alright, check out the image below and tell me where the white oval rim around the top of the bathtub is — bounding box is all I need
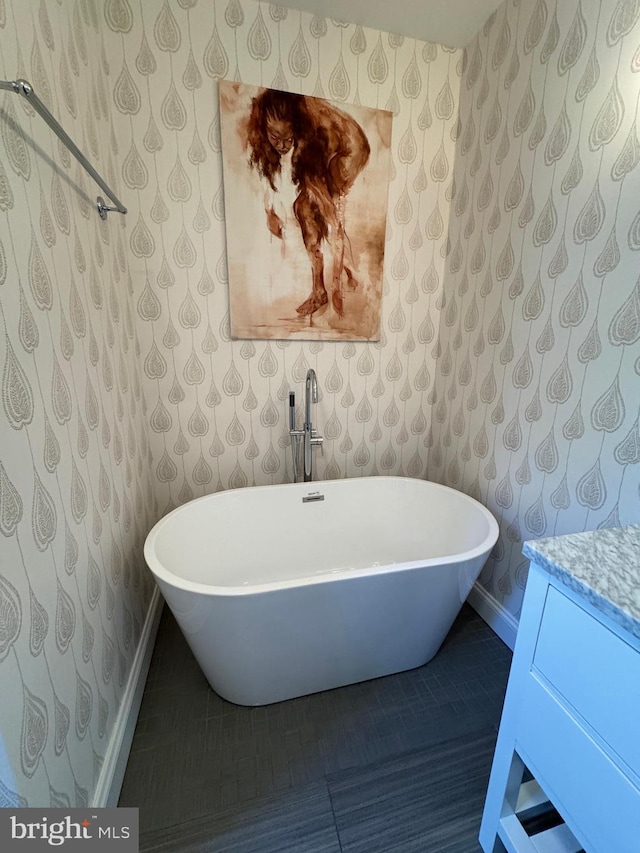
[144,477,500,597]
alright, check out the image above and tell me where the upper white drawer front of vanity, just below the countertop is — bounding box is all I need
[533,587,640,776]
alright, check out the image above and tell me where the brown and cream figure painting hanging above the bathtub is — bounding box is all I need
[220,80,392,341]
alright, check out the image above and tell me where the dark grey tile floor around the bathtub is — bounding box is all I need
[120,605,511,853]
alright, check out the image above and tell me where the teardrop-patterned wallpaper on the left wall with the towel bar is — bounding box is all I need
[0,0,155,807]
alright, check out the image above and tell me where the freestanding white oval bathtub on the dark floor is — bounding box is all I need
[144,477,498,705]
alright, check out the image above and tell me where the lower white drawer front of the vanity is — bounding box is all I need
[515,672,640,853]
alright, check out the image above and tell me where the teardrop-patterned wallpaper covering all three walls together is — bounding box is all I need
[0,0,640,806]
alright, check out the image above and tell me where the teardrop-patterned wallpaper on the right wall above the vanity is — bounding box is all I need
[428,0,640,615]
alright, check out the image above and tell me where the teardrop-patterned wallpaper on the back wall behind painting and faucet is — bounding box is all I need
[105,0,462,510]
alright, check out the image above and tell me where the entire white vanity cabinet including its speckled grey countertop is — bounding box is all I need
[480,528,640,853]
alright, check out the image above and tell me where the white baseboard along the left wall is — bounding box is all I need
[92,587,164,808]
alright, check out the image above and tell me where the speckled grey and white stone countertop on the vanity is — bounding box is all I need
[522,525,640,637]
